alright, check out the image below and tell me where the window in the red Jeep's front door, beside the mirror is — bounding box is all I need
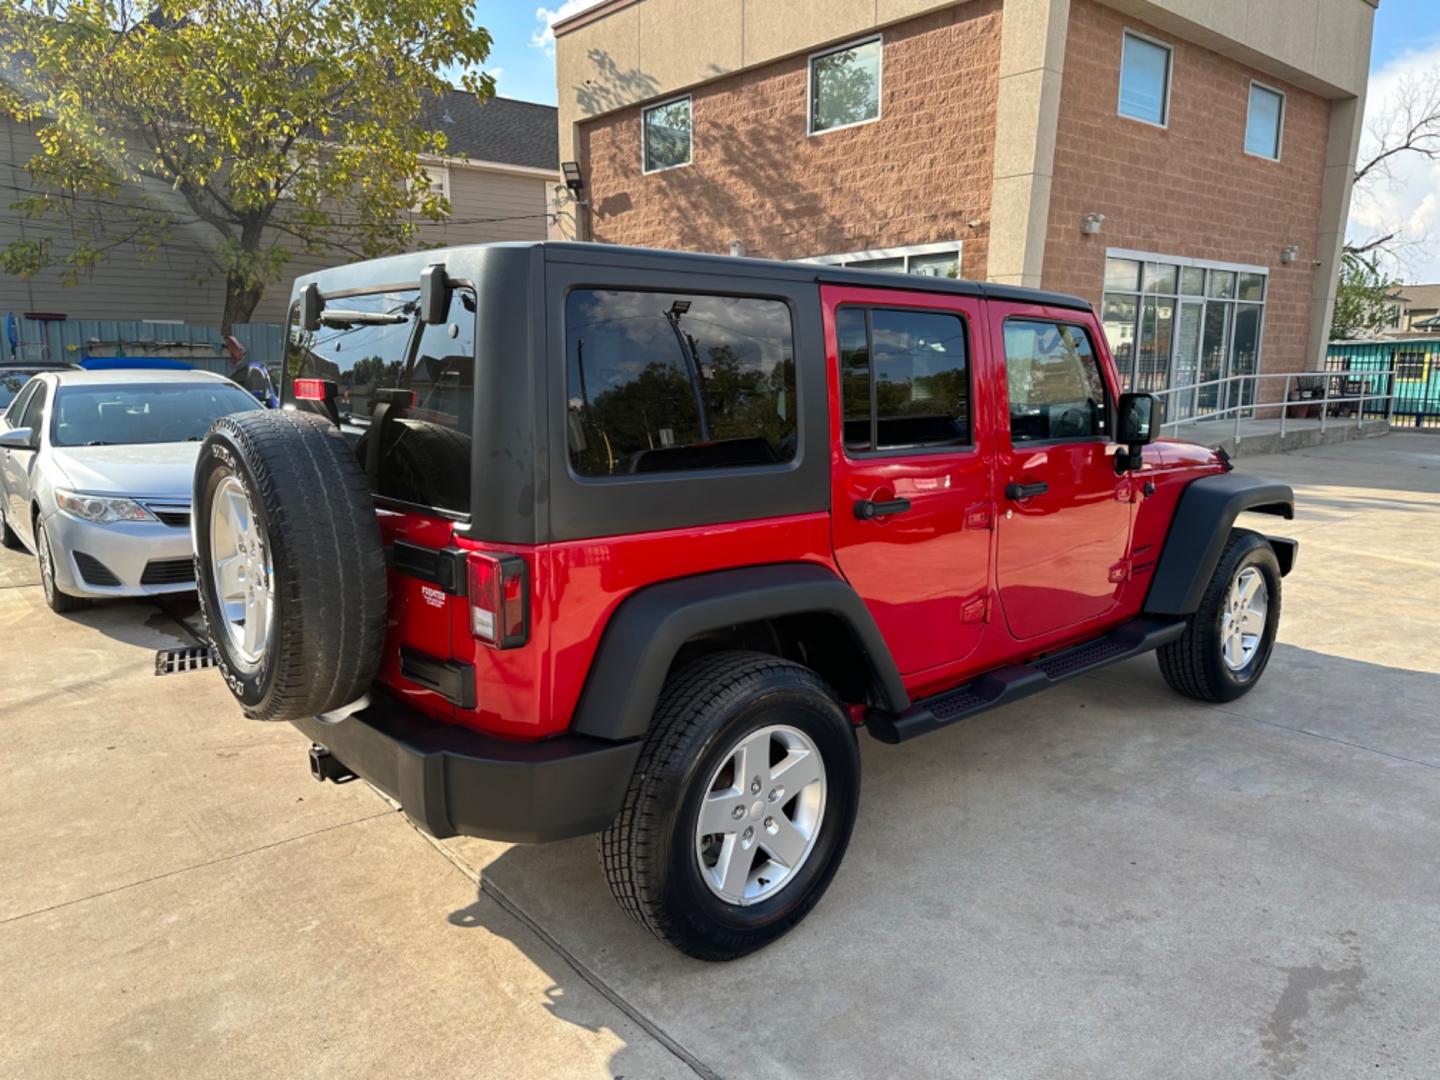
[1005,318,1110,444]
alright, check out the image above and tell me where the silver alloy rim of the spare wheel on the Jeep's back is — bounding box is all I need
[210,475,275,671]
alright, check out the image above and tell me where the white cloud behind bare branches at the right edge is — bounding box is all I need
[1346,42,1440,282]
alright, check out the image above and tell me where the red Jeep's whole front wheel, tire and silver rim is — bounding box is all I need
[1156,528,1280,703]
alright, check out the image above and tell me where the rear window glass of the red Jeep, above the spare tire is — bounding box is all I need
[282,288,475,514]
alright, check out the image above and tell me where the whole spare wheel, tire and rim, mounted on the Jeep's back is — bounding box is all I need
[192,412,386,720]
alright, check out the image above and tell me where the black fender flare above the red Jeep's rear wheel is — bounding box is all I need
[570,563,910,740]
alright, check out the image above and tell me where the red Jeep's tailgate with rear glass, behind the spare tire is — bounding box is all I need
[282,288,475,717]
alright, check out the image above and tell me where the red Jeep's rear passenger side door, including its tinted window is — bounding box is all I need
[824,287,994,674]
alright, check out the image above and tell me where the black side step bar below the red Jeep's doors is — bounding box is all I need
[865,619,1185,743]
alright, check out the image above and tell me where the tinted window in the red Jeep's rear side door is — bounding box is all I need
[835,308,971,452]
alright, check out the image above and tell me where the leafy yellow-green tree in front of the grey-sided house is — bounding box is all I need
[0,0,494,333]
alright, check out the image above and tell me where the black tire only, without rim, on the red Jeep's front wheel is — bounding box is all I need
[1156,528,1280,703]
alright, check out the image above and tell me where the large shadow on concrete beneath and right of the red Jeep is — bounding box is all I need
[448,645,1440,1077]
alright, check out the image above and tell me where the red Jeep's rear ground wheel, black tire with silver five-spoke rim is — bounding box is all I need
[600,652,860,960]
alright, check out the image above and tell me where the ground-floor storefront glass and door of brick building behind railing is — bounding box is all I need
[1100,251,1269,419]
